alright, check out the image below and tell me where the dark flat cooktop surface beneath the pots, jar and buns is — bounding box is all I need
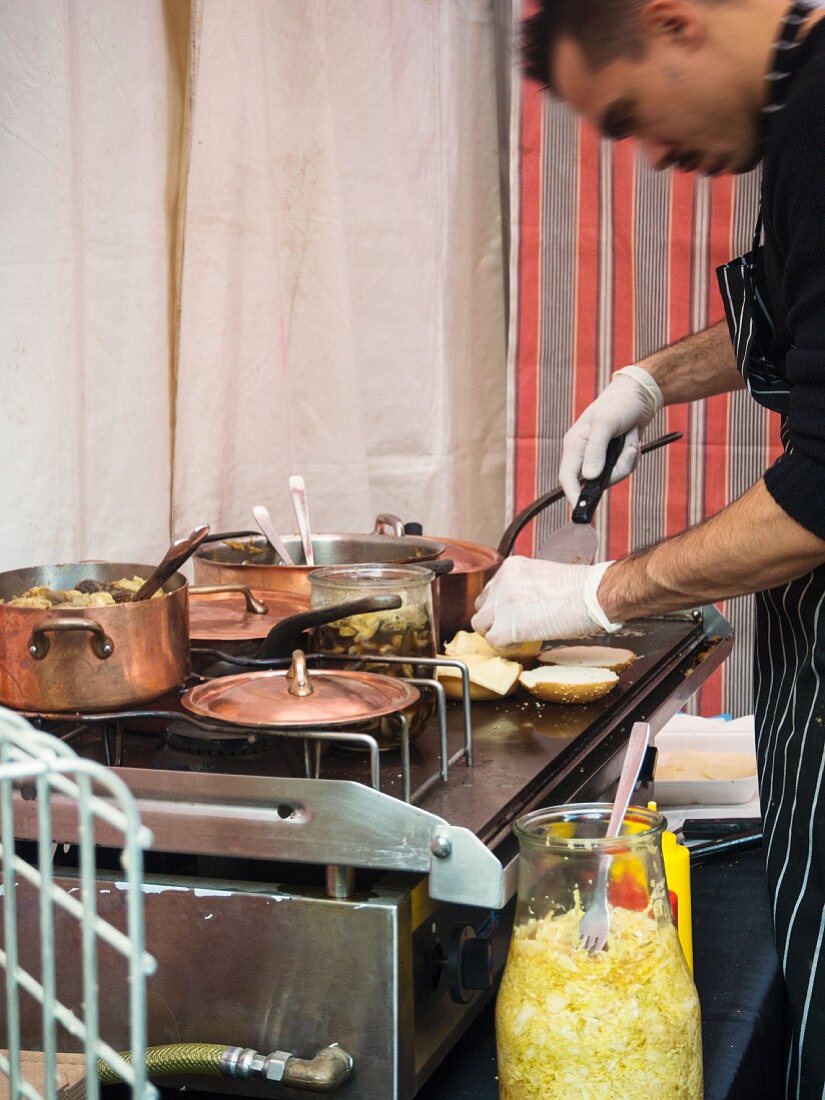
[40,618,727,844]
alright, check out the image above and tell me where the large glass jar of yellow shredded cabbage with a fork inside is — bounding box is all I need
[496,804,703,1100]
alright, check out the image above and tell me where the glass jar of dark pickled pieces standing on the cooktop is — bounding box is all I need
[309,564,436,748]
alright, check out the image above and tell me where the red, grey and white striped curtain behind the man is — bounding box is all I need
[509,75,780,715]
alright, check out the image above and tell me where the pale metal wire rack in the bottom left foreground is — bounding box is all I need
[0,708,157,1100]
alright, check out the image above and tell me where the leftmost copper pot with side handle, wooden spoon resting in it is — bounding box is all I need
[0,562,189,713]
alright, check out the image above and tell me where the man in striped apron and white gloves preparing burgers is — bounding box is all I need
[473,0,825,1098]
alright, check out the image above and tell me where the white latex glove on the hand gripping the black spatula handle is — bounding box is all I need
[559,364,663,507]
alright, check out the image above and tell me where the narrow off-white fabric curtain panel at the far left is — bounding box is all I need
[0,0,182,569]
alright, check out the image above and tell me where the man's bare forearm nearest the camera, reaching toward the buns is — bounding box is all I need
[598,480,825,623]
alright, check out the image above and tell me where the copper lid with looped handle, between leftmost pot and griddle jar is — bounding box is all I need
[189,584,309,641]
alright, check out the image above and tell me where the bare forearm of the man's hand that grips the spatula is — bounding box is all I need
[638,321,745,405]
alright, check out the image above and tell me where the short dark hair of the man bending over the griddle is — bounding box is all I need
[521,0,646,88]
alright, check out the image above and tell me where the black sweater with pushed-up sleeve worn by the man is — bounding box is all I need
[760,20,825,539]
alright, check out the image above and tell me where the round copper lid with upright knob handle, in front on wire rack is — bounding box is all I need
[180,650,419,729]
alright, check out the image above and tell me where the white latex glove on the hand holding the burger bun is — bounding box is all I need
[472,557,622,646]
